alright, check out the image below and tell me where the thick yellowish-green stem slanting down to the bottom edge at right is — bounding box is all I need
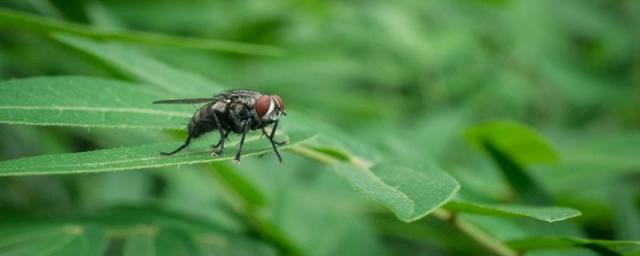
[433,208,519,256]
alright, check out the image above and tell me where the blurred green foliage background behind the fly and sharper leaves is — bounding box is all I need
[0,0,640,255]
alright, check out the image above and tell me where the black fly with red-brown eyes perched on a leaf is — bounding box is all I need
[153,90,286,163]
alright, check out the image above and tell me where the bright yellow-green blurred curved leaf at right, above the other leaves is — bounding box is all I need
[465,121,558,166]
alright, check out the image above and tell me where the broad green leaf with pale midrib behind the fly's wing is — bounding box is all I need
[0,76,193,129]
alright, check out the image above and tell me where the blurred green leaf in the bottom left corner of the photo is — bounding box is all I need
[0,224,107,256]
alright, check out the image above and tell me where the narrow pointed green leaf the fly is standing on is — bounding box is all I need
[0,131,314,176]
